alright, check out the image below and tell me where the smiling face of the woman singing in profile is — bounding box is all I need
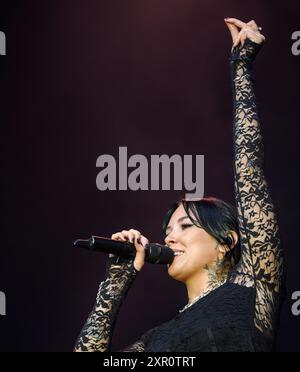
[165,204,219,282]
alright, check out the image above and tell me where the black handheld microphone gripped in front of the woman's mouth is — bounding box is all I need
[73,235,174,264]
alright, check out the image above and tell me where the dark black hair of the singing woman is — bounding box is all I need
[163,196,241,265]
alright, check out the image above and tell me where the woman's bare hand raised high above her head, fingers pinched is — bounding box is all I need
[224,18,266,51]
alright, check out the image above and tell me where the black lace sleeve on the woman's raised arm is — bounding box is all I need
[227,39,283,334]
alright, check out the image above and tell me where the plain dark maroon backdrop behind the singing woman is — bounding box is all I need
[0,0,300,351]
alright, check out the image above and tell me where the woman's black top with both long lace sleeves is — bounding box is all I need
[75,39,283,352]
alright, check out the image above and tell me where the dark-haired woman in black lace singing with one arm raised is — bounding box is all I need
[75,18,283,352]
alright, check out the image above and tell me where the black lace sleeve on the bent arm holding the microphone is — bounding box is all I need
[75,256,139,352]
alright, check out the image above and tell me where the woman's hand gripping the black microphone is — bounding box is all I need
[111,229,149,271]
